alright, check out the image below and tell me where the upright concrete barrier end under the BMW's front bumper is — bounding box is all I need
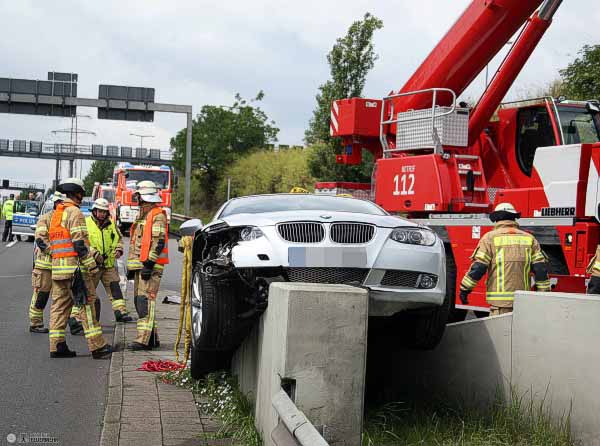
[232,283,368,446]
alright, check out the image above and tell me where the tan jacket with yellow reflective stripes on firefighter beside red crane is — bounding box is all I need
[461,221,550,307]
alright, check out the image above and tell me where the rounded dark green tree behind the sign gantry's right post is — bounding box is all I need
[171,91,279,208]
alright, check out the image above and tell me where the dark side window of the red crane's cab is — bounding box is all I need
[516,107,556,176]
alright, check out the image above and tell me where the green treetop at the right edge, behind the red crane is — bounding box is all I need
[560,45,600,100]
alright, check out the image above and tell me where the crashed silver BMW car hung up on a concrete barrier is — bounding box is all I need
[181,194,449,376]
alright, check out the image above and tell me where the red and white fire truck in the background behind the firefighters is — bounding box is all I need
[112,163,174,233]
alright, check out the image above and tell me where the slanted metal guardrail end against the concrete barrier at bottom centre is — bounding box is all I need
[271,389,329,446]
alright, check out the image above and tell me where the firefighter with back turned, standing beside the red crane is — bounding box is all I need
[460,203,550,316]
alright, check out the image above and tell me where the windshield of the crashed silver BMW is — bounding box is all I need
[218,194,387,218]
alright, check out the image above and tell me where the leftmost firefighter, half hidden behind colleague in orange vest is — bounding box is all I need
[29,192,65,333]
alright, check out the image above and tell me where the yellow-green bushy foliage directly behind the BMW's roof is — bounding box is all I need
[219,149,315,201]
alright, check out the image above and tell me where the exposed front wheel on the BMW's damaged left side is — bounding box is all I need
[190,262,251,376]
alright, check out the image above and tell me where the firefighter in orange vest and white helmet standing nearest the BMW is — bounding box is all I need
[127,181,169,350]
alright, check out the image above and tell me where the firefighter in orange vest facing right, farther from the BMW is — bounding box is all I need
[49,178,112,359]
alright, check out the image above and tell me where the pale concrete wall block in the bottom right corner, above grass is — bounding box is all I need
[513,292,600,445]
